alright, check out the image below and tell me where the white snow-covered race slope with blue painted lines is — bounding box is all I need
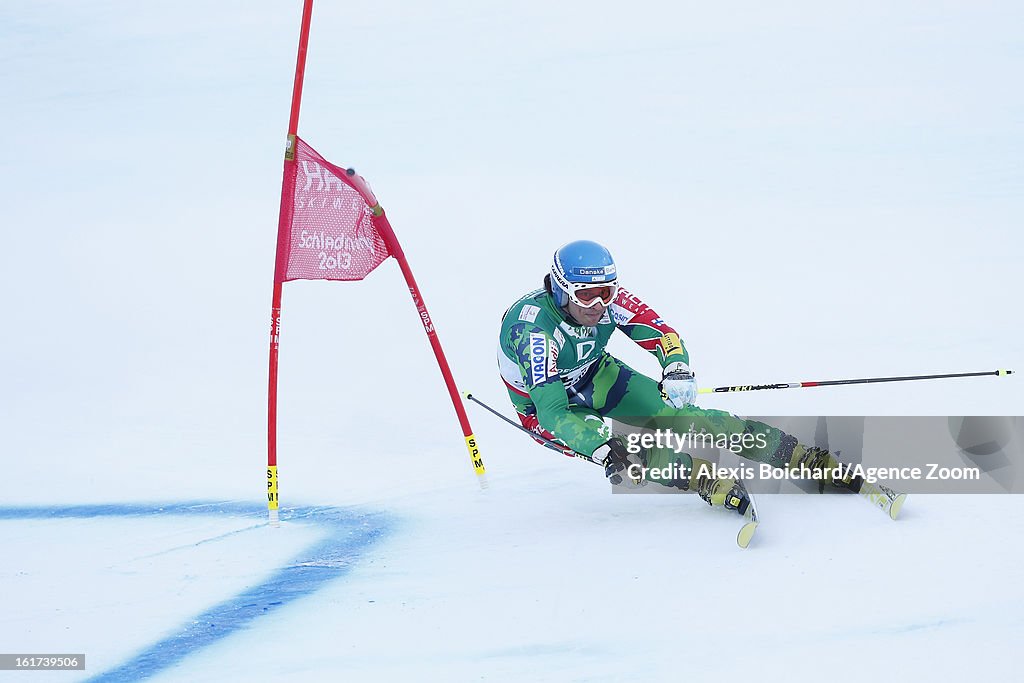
[0,0,1024,681]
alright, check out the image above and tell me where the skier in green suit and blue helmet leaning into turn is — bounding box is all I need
[498,240,859,514]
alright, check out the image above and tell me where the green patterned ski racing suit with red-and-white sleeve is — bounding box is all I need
[498,288,795,485]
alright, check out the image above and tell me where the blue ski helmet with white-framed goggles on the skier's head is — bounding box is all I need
[551,240,618,308]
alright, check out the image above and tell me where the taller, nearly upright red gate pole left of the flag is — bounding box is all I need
[266,0,313,526]
